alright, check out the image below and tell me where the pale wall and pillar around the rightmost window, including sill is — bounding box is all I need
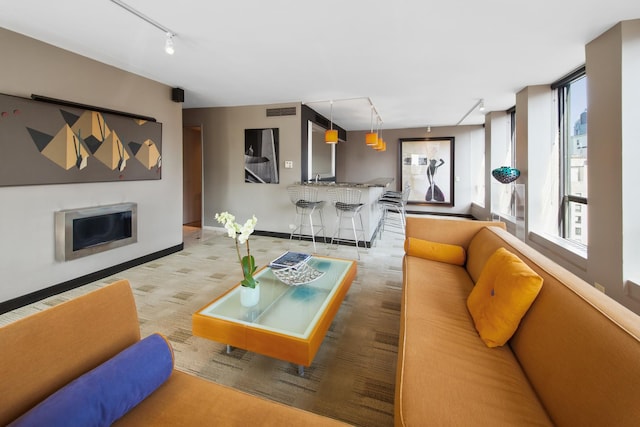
[496,20,640,313]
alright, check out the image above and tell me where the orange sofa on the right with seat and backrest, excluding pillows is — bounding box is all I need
[395,218,640,426]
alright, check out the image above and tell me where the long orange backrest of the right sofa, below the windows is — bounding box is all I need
[469,229,640,426]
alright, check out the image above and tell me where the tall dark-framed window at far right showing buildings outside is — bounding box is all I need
[552,67,588,245]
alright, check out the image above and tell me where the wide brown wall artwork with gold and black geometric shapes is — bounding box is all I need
[0,94,162,186]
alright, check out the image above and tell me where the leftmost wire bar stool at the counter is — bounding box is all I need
[287,185,327,252]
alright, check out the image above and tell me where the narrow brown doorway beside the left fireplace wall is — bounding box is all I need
[182,126,202,228]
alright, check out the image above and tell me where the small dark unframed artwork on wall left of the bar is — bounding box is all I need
[244,128,280,184]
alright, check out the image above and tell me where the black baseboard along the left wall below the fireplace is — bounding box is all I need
[0,243,184,314]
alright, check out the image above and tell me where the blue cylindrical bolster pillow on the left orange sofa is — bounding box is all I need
[10,334,173,427]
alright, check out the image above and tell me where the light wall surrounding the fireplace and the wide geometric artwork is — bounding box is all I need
[0,28,182,302]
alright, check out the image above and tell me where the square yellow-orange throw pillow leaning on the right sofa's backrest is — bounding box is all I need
[467,248,542,347]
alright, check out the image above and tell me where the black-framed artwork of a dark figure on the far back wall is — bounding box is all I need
[399,137,455,206]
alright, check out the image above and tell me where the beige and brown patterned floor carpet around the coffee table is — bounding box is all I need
[0,228,404,426]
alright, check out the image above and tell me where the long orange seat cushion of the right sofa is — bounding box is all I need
[394,252,552,426]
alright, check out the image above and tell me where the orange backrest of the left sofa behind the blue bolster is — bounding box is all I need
[0,281,140,425]
